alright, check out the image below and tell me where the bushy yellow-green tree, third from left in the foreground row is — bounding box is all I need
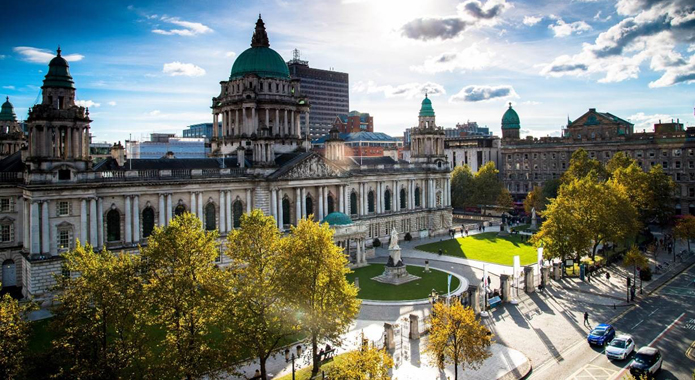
[142,213,228,379]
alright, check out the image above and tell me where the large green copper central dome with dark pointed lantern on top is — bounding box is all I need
[229,15,290,80]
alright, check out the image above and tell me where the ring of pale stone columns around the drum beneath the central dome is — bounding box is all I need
[212,106,309,138]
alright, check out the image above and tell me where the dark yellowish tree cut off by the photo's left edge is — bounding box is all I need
[0,284,34,379]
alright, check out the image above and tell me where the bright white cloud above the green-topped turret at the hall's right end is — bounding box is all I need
[410,43,495,74]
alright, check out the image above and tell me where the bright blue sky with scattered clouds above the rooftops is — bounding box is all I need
[0,0,695,142]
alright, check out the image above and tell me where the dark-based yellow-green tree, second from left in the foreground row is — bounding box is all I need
[53,242,150,379]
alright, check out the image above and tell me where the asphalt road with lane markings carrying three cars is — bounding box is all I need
[530,265,695,380]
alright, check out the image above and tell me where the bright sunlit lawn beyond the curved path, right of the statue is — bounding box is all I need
[416,232,538,266]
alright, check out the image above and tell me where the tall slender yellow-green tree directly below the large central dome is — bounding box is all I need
[225,210,298,379]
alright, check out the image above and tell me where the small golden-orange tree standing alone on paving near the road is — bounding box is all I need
[424,302,492,379]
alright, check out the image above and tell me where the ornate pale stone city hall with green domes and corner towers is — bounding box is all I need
[0,18,452,296]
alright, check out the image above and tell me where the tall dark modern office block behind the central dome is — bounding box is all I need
[287,49,350,139]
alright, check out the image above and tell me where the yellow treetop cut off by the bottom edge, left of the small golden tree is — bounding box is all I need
[328,343,394,380]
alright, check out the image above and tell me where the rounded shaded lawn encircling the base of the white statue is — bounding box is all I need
[347,264,460,301]
